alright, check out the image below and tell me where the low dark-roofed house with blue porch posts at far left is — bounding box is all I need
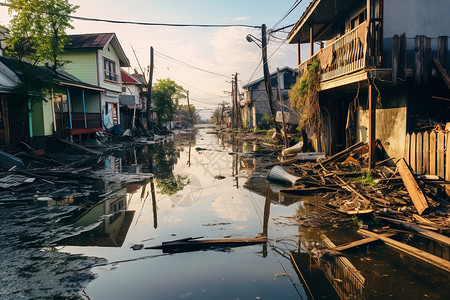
[0,56,102,144]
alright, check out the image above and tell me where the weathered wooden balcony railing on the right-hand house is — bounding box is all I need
[299,21,368,81]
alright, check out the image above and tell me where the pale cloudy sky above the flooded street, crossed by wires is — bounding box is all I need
[0,0,311,118]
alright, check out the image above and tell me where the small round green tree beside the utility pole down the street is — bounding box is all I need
[152,78,186,125]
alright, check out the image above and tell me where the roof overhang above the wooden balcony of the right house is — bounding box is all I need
[288,0,365,44]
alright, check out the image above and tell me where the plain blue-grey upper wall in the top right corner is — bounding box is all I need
[383,0,450,38]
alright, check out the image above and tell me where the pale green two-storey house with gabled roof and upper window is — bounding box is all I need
[61,33,130,129]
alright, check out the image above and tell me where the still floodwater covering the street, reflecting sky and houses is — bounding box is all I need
[0,128,450,299]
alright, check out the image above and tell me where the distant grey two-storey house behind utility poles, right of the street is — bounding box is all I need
[241,67,298,128]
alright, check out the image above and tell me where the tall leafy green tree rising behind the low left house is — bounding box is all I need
[5,0,79,73]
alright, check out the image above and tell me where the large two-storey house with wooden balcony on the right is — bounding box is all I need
[288,0,450,172]
